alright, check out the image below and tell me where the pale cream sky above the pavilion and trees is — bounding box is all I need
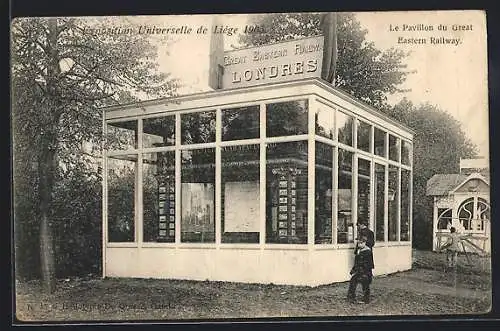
[116,11,489,157]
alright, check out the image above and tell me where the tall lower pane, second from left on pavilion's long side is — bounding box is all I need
[142,152,176,242]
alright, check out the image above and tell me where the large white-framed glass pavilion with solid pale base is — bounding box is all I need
[103,35,412,285]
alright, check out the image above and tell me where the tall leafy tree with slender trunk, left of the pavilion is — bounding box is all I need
[11,18,176,291]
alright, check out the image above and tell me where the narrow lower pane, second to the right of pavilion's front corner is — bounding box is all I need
[337,148,354,244]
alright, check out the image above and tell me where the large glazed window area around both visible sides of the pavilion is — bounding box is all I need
[106,94,412,248]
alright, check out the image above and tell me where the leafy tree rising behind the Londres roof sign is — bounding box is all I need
[240,13,409,107]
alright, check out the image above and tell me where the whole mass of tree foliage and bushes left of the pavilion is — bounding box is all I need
[11,18,177,278]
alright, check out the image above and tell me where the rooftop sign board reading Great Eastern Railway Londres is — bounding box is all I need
[222,36,323,89]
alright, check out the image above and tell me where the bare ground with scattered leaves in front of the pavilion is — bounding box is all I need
[16,251,491,321]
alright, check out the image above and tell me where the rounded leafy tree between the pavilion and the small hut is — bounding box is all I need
[389,99,478,248]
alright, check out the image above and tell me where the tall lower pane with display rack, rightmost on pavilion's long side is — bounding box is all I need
[266,141,308,244]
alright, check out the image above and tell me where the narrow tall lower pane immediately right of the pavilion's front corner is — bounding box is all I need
[314,142,333,244]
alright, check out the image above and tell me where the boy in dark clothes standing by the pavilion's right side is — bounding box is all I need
[347,236,374,303]
